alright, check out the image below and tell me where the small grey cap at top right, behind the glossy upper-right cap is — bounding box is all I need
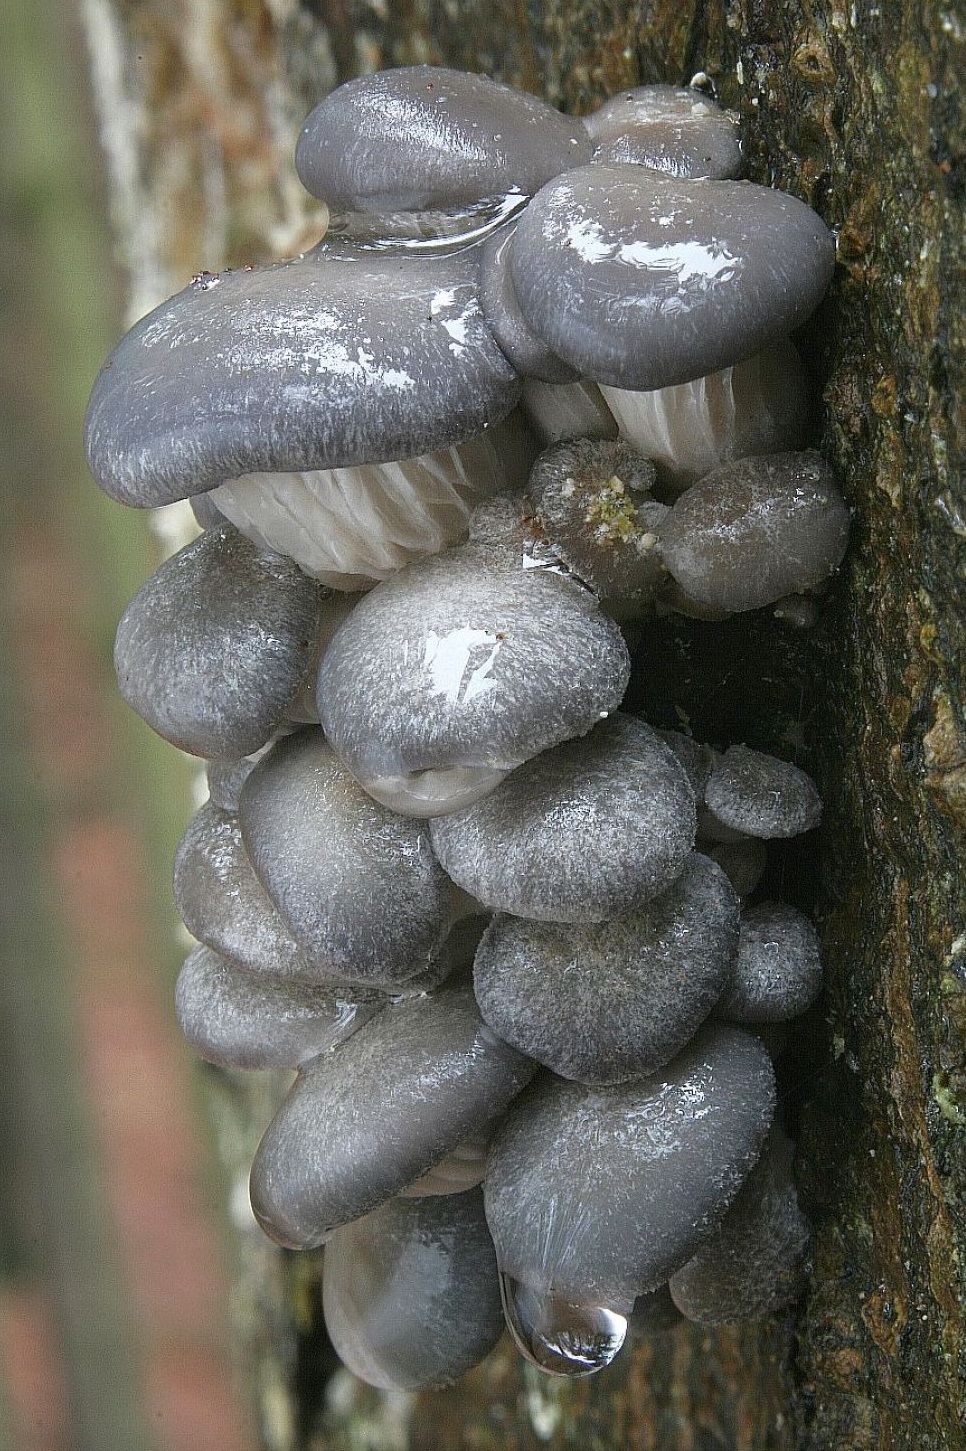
[583,86,741,180]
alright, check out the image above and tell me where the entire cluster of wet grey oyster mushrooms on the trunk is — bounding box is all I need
[87,67,849,1389]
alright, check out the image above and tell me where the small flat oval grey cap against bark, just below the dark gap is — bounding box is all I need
[701,746,822,840]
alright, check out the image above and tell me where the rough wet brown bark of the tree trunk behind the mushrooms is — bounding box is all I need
[81,0,966,1451]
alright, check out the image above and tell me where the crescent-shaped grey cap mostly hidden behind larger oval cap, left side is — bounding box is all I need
[174,801,319,982]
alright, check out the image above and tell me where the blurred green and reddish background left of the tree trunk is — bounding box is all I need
[0,0,255,1451]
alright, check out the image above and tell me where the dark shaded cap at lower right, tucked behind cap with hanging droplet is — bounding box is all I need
[670,1129,809,1325]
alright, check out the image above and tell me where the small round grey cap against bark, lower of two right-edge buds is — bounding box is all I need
[717,903,822,1023]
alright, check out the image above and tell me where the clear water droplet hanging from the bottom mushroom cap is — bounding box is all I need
[500,1274,627,1376]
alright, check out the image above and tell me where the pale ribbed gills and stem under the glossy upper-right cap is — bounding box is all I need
[600,338,812,493]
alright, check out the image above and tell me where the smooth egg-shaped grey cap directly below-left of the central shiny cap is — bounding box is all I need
[239,730,453,987]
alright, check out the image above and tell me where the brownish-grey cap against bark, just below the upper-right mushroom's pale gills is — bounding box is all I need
[657,450,849,611]
